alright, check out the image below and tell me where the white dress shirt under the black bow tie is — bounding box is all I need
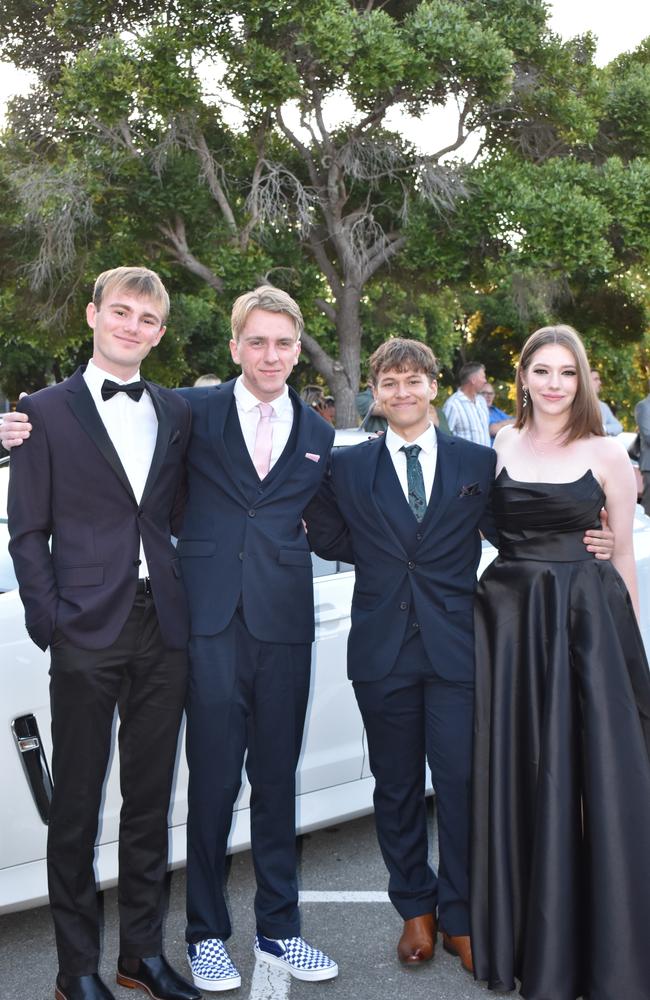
[83,359,158,578]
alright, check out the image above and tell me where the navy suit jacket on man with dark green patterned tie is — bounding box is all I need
[305,432,496,682]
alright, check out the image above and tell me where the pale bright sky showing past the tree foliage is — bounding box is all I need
[0,0,650,131]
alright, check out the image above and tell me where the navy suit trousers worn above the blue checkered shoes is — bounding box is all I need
[186,611,311,942]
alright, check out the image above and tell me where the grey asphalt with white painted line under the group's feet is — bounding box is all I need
[0,816,496,1000]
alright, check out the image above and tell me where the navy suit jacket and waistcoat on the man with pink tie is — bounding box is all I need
[178,380,334,643]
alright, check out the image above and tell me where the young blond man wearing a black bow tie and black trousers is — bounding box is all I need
[8,267,200,1000]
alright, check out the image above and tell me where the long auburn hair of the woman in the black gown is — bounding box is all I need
[515,324,605,444]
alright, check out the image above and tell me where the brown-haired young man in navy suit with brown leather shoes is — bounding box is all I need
[305,338,611,971]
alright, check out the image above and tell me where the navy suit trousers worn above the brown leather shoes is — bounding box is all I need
[354,634,474,935]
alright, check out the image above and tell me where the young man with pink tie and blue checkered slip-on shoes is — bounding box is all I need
[178,286,338,990]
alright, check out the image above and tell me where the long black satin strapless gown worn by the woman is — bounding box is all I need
[471,469,650,1000]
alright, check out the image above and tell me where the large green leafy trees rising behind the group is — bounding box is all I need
[0,0,650,424]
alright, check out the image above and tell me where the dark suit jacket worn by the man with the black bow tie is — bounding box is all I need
[8,368,191,649]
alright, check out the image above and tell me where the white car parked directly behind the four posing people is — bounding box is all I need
[0,440,650,913]
